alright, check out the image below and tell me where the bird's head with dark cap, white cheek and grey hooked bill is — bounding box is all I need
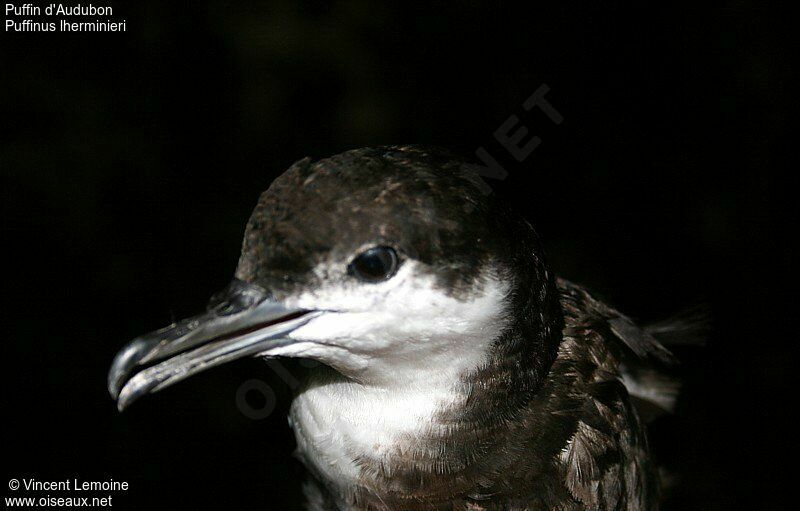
[108,146,558,409]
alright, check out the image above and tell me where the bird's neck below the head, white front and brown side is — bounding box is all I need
[291,276,561,508]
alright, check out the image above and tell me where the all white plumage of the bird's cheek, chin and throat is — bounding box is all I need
[265,262,508,494]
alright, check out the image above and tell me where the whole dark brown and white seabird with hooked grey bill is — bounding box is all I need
[108,145,677,511]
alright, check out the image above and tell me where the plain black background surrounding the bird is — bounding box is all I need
[0,1,797,510]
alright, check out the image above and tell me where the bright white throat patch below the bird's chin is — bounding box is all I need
[290,348,494,504]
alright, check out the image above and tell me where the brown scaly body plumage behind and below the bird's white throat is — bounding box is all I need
[306,279,670,511]
